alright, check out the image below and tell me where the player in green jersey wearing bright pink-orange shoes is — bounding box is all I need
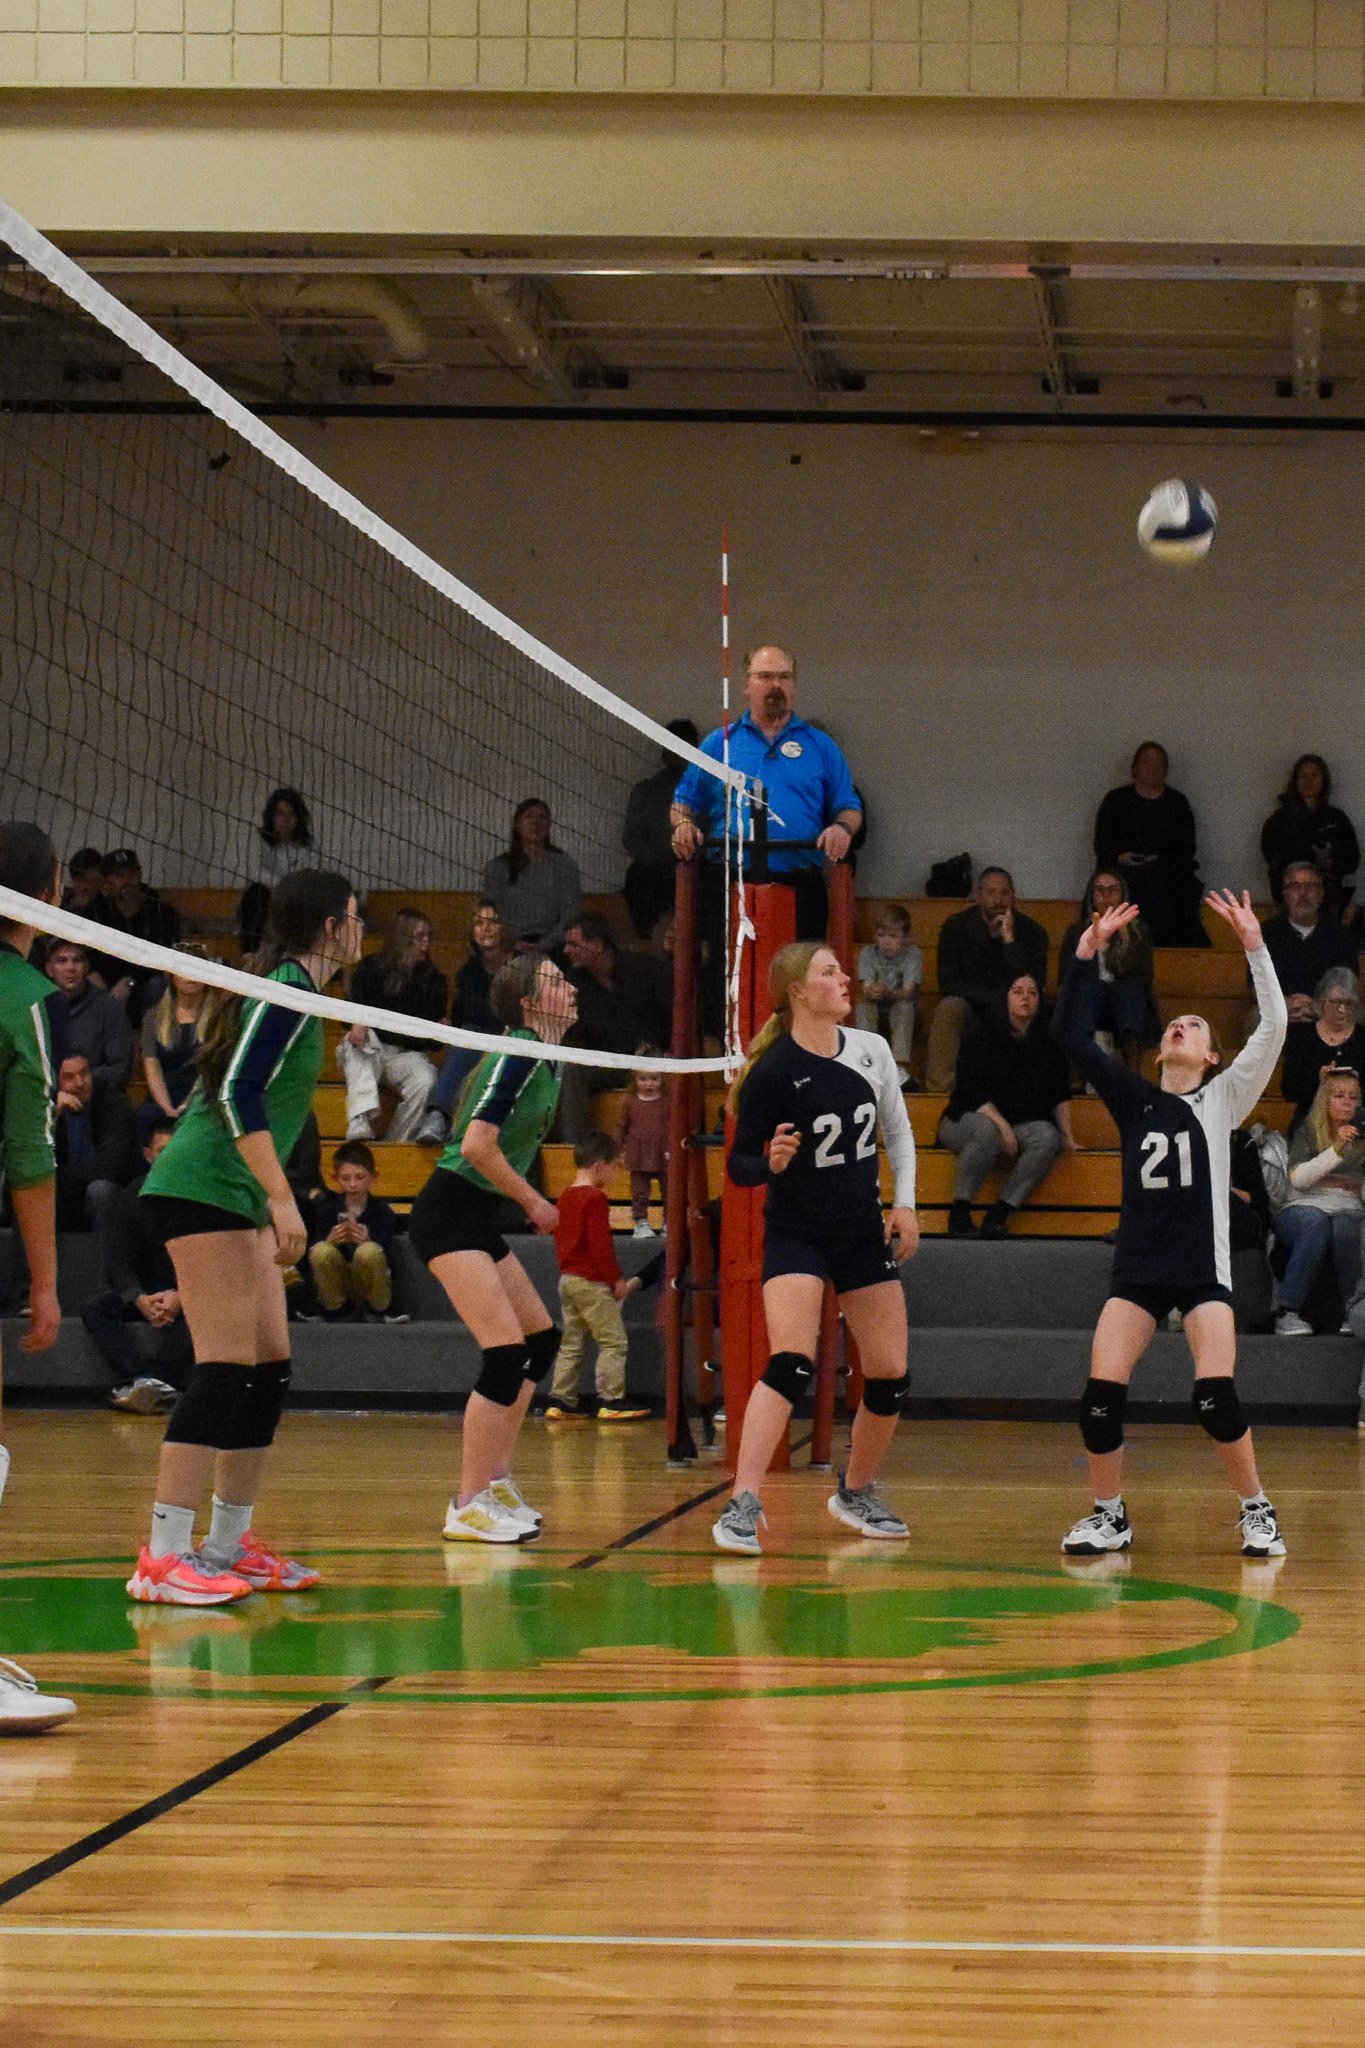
[129,868,362,1608]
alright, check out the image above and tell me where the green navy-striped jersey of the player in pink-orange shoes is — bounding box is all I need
[143,961,323,1229]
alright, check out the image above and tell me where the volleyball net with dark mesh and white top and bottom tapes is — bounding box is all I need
[0,205,747,1071]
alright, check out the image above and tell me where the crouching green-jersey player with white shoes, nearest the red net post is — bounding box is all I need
[407,954,577,1542]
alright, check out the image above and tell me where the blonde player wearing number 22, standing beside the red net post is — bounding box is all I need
[712,940,919,1554]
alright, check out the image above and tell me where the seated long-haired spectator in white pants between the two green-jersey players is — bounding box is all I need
[336,909,448,1145]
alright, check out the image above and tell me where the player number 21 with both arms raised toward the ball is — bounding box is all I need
[1052,889,1287,1556]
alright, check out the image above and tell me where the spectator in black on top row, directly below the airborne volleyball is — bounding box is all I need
[1095,739,1209,946]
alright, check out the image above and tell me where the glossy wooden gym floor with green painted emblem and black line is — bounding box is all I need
[0,1411,1365,2048]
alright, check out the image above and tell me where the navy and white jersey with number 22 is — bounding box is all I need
[729,1030,915,1239]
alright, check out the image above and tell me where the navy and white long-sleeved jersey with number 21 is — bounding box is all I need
[1052,946,1287,1288]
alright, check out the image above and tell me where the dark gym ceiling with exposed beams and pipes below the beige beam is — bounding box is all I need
[0,238,1365,424]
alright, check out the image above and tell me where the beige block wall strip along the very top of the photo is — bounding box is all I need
[0,0,1365,100]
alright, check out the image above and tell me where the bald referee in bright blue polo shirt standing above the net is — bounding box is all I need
[671,647,862,1034]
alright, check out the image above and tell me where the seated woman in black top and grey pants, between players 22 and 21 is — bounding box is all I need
[939,975,1076,1237]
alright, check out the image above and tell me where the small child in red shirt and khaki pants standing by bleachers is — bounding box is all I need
[546,1130,649,1421]
